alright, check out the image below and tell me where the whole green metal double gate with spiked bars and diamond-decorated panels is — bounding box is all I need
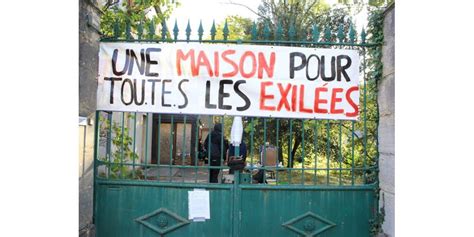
[94,19,380,237]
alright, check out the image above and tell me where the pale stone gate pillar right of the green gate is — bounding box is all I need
[378,5,395,237]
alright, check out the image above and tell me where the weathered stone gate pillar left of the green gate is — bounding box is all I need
[78,0,105,236]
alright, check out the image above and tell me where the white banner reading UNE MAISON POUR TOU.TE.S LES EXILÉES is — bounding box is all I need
[97,42,359,120]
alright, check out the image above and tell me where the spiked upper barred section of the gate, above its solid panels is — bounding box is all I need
[95,19,380,186]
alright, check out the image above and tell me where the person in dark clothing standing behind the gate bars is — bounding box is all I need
[204,123,229,183]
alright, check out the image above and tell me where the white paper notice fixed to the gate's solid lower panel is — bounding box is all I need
[188,189,211,221]
